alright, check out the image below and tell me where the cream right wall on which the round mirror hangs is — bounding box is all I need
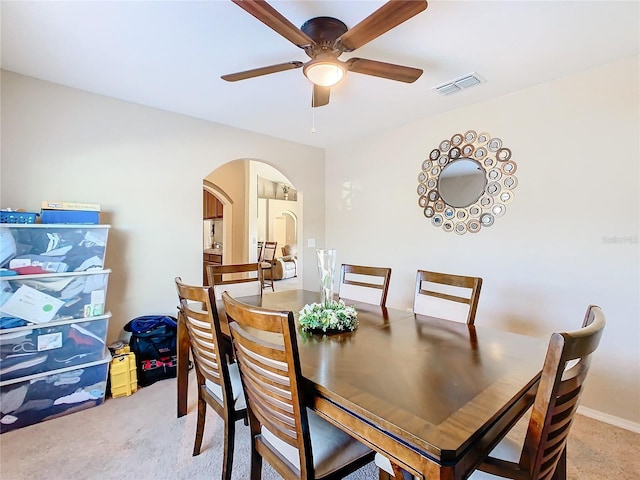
[326,54,640,427]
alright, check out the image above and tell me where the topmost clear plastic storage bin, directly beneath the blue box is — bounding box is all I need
[0,224,110,275]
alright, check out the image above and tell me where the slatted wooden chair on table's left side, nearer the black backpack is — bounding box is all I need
[175,277,247,480]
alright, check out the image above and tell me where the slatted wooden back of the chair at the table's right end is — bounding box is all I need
[520,305,606,480]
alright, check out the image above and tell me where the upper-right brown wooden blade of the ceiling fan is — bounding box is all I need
[337,0,427,52]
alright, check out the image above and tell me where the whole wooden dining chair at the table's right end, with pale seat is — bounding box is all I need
[376,305,606,480]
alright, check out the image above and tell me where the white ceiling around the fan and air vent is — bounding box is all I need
[0,0,640,147]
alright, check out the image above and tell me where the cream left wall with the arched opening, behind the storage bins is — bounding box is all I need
[0,71,324,340]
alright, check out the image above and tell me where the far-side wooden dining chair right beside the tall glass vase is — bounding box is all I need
[339,263,391,307]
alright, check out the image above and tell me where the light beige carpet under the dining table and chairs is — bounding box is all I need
[0,372,640,480]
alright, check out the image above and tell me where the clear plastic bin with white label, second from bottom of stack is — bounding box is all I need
[0,313,111,381]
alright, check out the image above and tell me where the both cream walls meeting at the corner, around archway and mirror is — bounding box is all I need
[0,58,640,425]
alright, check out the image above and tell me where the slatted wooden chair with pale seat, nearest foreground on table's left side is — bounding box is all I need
[222,292,374,480]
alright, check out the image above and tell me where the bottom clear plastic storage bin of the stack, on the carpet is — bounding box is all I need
[0,350,111,433]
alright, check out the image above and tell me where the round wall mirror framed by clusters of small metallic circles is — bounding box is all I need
[417,130,518,235]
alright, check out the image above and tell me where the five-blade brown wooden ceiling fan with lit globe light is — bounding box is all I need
[222,0,427,107]
